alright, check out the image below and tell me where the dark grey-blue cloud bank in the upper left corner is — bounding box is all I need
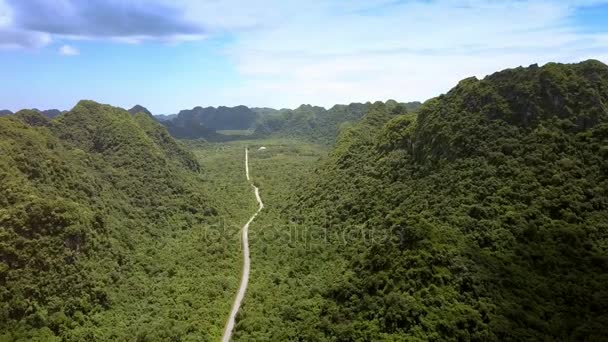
[0,0,205,48]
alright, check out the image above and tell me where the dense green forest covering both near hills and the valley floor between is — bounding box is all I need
[0,61,608,341]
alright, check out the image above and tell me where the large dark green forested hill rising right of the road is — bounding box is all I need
[243,61,608,341]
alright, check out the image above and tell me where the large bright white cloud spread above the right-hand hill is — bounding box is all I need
[194,0,608,107]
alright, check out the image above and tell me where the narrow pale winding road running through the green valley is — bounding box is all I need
[222,148,264,342]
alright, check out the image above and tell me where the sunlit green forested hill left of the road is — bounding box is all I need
[0,101,236,341]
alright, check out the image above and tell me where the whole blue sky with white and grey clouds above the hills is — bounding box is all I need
[0,0,608,114]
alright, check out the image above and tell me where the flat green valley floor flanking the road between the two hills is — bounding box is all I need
[190,139,327,341]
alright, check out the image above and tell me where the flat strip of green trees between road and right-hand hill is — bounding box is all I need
[233,139,338,341]
